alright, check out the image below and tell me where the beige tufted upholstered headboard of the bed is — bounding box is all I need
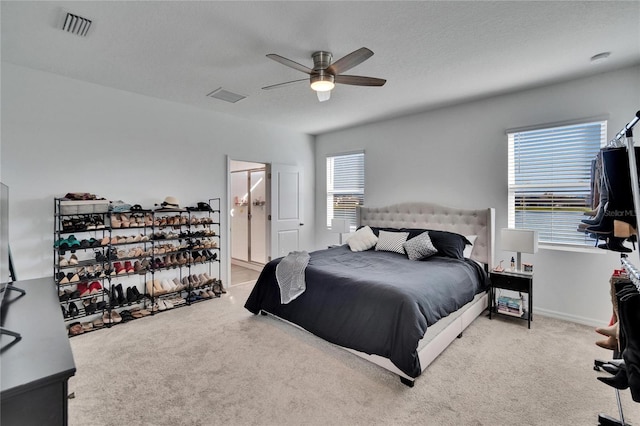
[358,202,495,268]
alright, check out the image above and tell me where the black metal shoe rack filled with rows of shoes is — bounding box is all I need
[53,198,224,337]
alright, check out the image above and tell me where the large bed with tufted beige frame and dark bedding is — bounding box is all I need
[245,203,495,386]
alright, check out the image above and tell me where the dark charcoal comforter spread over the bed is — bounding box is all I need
[245,245,488,377]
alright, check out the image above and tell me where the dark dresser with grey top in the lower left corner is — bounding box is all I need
[0,278,76,426]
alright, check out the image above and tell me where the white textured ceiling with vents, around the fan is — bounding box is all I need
[0,0,640,134]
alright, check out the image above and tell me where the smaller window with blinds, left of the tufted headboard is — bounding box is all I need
[327,152,364,230]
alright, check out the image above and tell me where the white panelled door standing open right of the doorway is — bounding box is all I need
[270,164,304,259]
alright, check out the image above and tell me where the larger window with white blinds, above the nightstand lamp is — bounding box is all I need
[508,121,607,246]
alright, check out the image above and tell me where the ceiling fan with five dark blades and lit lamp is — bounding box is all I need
[263,47,387,102]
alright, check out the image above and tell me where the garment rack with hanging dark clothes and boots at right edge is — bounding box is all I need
[585,111,640,426]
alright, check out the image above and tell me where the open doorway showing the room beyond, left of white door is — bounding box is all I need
[229,160,270,285]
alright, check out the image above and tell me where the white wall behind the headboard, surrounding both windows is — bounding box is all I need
[316,67,640,326]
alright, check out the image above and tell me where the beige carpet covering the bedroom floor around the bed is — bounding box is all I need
[69,284,640,426]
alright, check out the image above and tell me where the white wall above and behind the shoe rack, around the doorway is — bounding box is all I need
[0,63,314,283]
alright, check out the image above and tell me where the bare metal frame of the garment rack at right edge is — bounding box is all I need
[593,111,640,426]
